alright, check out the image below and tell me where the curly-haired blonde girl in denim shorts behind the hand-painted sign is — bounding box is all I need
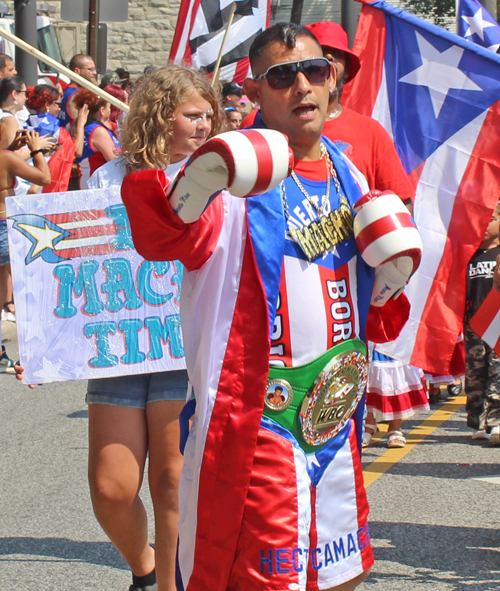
[87,66,222,591]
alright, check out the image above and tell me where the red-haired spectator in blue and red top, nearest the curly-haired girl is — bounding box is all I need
[73,90,120,189]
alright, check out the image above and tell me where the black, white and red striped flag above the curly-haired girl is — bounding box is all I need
[169,0,271,84]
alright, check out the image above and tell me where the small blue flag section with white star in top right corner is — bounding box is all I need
[457,0,500,53]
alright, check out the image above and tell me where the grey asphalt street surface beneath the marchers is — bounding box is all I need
[0,322,500,591]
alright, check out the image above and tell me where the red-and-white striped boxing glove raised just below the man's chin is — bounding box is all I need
[168,129,293,223]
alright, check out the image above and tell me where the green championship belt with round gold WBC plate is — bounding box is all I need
[264,339,368,453]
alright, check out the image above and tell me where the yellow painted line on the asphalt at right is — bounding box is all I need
[363,396,466,487]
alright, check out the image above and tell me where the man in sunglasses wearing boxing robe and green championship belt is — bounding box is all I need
[122,23,420,591]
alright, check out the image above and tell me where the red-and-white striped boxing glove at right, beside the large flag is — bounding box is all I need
[354,191,423,306]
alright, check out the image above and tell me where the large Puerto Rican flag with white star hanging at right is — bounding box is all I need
[343,0,500,374]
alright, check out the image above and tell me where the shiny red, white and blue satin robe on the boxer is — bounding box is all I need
[122,138,410,591]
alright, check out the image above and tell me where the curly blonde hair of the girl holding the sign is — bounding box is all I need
[120,65,224,173]
